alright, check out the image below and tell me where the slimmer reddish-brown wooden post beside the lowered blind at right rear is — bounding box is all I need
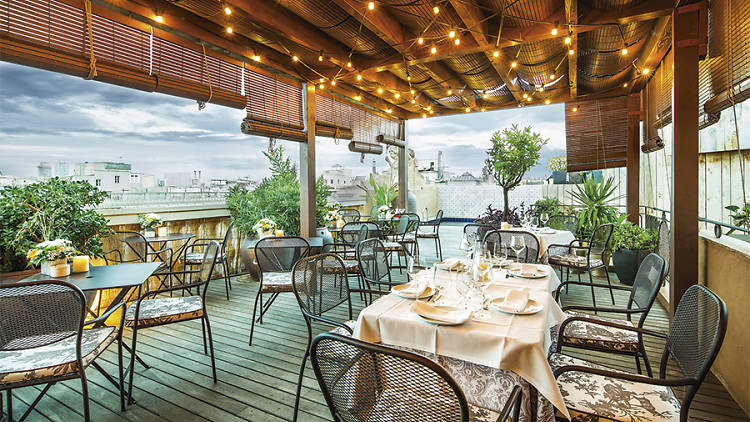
[627,93,641,224]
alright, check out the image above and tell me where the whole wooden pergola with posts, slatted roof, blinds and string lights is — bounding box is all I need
[0,0,724,310]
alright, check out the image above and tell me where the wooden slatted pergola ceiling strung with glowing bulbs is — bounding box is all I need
[75,0,676,118]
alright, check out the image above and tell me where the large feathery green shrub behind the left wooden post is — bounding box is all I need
[226,145,331,235]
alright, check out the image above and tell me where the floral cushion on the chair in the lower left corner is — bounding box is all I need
[0,327,117,385]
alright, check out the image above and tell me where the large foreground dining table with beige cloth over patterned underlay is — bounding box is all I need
[353,264,569,422]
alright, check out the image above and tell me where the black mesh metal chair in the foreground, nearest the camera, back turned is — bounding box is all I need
[310,333,522,422]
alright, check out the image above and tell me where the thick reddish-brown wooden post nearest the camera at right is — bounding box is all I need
[669,3,700,313]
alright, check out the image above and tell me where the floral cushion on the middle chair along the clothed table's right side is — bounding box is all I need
[562,311,638,353]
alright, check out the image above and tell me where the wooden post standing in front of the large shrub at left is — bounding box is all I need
[299,84,317,236]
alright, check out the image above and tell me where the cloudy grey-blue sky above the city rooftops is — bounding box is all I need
[0,62,565,179]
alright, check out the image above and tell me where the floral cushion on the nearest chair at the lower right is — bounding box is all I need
[550,354,680,422]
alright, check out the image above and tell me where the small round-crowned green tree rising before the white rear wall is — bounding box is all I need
[484,125,549,215]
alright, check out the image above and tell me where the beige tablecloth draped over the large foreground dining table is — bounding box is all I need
[354,270,567,415]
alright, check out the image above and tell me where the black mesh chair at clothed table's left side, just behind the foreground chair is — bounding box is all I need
[292,254,384,420]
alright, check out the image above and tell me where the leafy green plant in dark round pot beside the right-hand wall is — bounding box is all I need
[610,221,659,286]
